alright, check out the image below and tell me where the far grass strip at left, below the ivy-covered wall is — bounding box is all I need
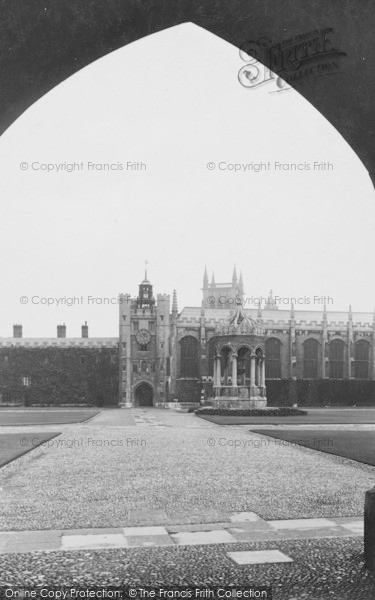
[0,407,100,427]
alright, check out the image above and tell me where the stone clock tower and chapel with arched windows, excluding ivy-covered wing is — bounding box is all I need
[120,270,375,406]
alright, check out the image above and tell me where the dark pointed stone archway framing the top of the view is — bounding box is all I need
[0,0,375,185]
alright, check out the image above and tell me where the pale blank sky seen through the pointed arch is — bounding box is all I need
[0,23,375,337]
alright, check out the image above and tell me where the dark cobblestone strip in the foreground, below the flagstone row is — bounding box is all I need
[0,537,375,600]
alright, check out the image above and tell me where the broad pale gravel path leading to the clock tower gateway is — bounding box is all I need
[0,409,375,531]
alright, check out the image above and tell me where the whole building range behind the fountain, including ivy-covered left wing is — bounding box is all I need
[0,271,375,407]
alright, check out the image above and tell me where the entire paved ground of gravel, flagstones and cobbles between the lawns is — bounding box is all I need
[0,409,375,599]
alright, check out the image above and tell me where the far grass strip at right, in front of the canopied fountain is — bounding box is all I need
[199,407,375,425]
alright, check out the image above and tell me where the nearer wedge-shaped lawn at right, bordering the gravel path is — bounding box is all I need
[256,429,375,466]
